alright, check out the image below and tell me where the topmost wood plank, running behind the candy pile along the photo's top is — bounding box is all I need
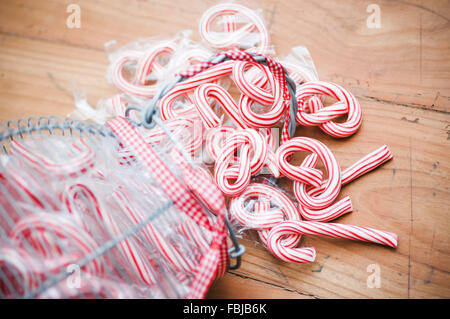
[0,0,450,112]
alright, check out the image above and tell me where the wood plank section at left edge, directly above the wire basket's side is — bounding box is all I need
[0,34,115,120]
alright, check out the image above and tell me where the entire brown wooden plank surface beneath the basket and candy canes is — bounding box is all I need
[0,0,450,298]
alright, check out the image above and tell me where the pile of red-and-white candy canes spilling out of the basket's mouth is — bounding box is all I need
[75,3,397,262]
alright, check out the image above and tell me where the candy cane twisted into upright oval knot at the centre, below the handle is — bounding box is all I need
[214,129,267,196]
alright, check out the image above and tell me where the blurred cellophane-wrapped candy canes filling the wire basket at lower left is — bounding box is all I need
[0,118,225,298]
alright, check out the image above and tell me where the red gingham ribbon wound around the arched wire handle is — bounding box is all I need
[179,50,291,143]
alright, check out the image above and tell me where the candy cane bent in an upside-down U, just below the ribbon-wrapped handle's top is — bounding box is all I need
[194,83,247,128]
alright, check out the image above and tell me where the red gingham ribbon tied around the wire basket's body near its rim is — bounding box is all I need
[107,117,228,298]
